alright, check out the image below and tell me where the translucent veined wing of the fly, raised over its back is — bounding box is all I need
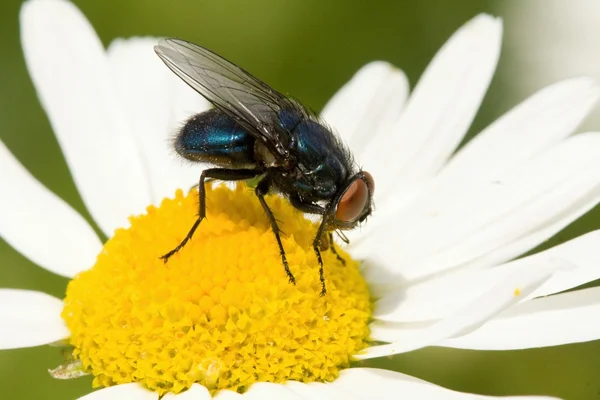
[154,39,308,160]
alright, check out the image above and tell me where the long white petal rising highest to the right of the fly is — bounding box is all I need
[360,14,502,204]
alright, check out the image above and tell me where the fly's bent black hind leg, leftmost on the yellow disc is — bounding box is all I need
[160,168,262,263]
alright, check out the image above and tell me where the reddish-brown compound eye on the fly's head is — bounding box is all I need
[335,171,375,222]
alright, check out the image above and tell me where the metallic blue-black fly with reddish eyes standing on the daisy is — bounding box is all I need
[154,39,375,296]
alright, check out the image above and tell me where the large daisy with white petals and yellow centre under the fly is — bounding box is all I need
[0,0,600,400]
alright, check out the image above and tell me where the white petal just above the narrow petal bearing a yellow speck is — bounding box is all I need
[374,231,600,323]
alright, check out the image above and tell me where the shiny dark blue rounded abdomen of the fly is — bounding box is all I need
[175,109,254,168]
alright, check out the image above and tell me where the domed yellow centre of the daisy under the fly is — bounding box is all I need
[62,184,371,395]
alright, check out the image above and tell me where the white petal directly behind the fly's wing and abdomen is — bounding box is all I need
[108,38,210,204]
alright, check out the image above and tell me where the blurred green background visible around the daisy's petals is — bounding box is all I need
[0,0,600,399]
